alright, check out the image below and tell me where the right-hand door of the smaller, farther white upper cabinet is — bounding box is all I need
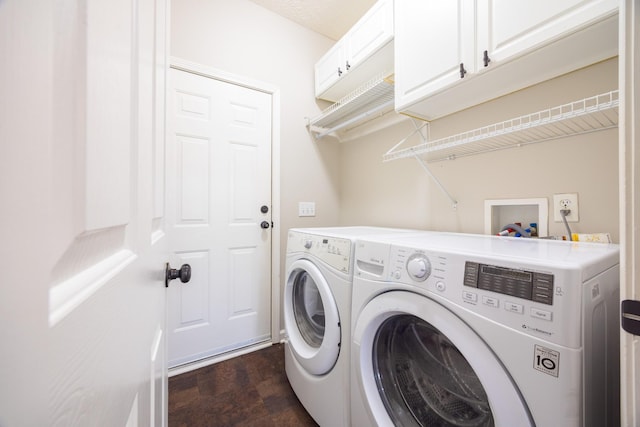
[345,0,393,71]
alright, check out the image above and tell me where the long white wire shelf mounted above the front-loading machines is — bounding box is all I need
[383,90,619,163]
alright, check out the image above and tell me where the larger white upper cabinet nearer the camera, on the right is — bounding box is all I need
[394,0,618,120]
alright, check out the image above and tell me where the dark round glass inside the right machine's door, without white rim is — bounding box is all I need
[373,315,494,427]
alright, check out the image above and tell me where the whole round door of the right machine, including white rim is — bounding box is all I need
[353,291,534,427]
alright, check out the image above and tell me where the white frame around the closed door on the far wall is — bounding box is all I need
[167,56,282,358]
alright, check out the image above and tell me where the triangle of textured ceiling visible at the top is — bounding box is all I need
[245,0,376,40]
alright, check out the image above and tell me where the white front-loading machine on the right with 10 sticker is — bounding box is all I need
[351,233,620,427]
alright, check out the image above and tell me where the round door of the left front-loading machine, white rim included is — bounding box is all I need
[284,259,340,375]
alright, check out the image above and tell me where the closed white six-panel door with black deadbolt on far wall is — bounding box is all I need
[167,68,272,366]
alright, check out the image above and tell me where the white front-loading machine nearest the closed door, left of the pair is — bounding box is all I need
[283,227,410,427]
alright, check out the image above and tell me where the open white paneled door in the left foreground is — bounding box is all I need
[0,0,168,426]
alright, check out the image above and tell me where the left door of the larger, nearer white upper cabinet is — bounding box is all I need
[394,0,476,110]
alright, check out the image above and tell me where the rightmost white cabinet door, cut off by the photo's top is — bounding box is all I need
[478,0,618,63]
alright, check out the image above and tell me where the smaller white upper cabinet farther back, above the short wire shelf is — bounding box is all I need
[315,0,393,102]
